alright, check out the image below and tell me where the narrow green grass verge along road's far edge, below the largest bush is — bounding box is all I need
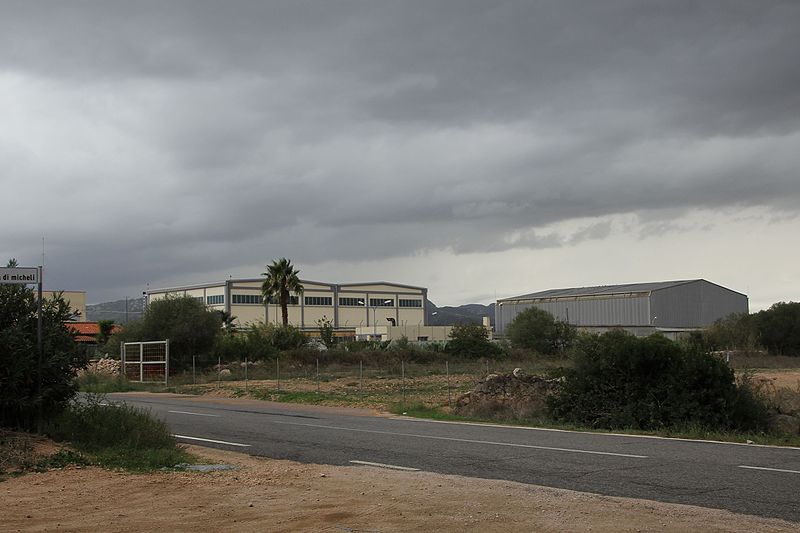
[389,403,800,447]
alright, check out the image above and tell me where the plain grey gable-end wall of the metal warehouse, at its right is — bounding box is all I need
[651,280,748,328]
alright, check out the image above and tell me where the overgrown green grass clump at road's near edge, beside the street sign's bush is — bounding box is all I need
[46,390,195,471]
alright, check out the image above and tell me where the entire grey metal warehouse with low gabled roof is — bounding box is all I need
[495,279,748,337]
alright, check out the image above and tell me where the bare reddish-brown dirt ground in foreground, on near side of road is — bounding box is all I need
[0,440,800,532]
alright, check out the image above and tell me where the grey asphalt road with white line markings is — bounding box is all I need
[109,393,800,522]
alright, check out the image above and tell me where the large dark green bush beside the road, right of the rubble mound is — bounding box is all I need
[550,331,767,430]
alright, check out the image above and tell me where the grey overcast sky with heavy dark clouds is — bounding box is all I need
[0,0,800,310]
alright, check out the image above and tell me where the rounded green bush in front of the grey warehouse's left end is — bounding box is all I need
[506,307,577,355]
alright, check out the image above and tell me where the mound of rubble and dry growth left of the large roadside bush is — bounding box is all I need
[454,368,561,420]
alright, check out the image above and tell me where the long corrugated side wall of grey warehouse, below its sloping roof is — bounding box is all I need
[495,293,650,334]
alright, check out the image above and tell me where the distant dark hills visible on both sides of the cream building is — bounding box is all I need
[86,298,494,326]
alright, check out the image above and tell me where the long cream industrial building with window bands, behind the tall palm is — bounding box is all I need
[146,278,428,340]
